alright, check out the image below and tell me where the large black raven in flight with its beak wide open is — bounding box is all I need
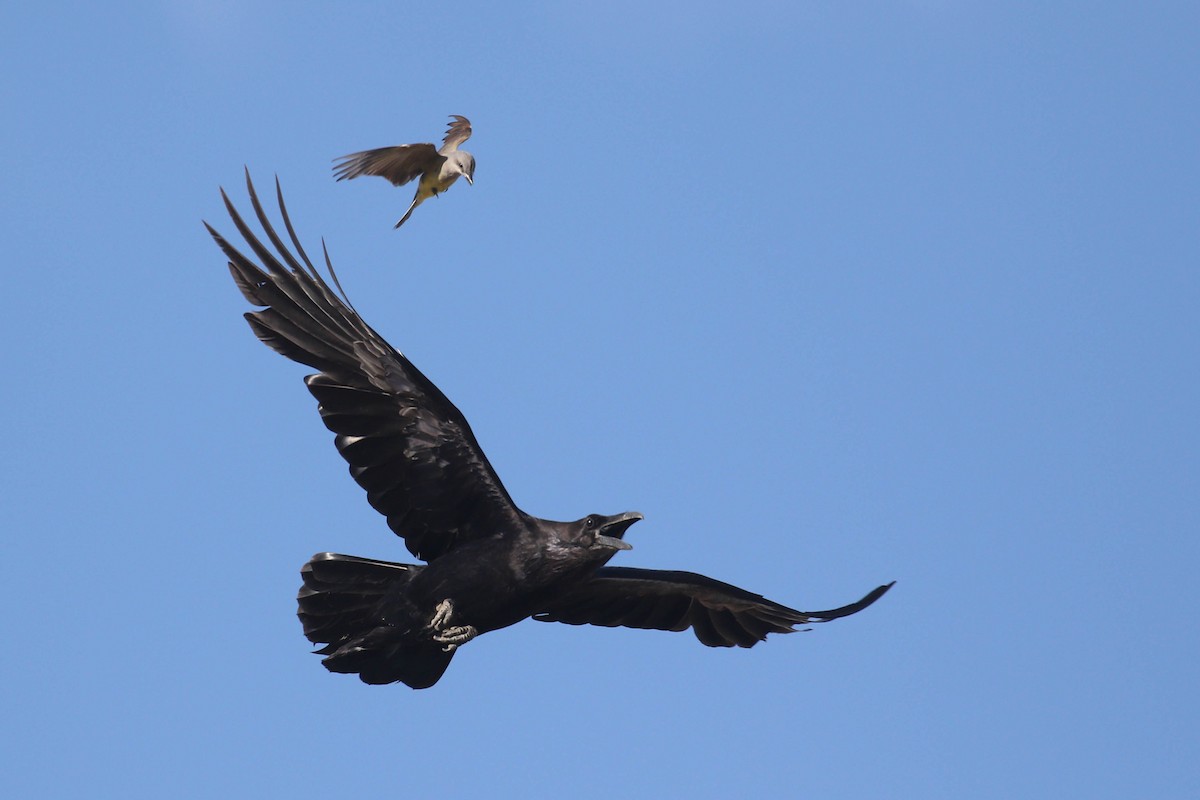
[205,172,892,688]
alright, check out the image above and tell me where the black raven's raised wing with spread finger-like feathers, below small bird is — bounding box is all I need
[205,172,524,561]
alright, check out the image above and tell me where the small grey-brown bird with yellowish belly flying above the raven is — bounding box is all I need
[334,114,475,228]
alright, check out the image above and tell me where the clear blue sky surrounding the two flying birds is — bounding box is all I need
[0,0,1200,800]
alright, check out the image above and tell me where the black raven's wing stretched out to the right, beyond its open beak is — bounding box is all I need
[534,566,892,648]
